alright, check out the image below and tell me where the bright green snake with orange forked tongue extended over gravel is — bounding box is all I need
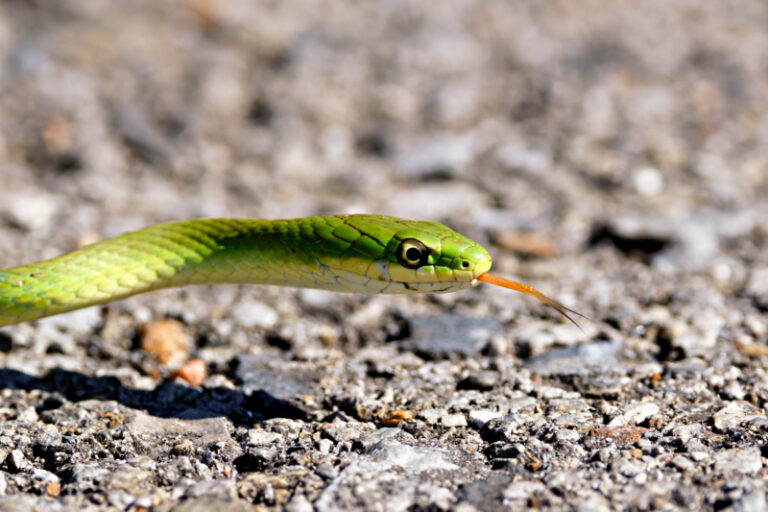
[0,215,578,326]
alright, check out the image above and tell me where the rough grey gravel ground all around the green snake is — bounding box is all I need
[0,0,768,512]
